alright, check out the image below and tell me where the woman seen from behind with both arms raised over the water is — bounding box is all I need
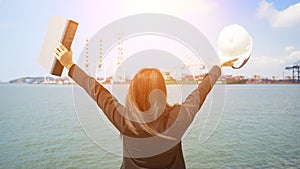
[55,44,237,169]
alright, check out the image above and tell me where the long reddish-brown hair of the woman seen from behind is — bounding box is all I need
[125,68,167,135]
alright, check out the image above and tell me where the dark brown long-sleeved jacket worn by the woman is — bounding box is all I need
[69,65,221,169]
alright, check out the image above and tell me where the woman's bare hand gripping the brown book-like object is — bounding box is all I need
[55,43,74,69]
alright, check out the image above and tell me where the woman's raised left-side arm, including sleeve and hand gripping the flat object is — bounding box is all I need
[55,44,124,131]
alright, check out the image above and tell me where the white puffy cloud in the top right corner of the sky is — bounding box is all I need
[256,0,300,27]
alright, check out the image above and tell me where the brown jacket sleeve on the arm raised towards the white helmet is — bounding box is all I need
[180,66,221,123]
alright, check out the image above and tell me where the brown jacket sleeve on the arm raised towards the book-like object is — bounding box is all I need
[68,64,125,132]
